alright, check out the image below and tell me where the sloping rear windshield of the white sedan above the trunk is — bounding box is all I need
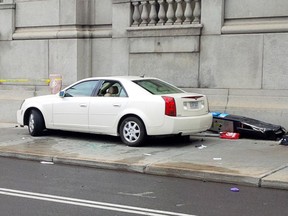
[134,79,184,95]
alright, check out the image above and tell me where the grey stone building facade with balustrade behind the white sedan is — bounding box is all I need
[0,0,288,128]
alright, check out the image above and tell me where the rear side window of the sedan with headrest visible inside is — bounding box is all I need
[97,80,128,97]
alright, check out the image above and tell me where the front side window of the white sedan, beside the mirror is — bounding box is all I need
[65,80,99,97]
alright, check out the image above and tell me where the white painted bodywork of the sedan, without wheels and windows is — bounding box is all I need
[17,76,212,147]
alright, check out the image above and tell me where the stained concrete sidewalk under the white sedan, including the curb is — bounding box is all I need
[0,123,288,189]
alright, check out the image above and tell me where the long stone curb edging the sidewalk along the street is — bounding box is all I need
[0,152,280,190]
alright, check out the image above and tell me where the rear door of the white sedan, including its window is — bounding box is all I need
[89,80,128,134]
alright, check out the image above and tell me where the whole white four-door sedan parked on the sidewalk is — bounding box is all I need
[17,76,212,146]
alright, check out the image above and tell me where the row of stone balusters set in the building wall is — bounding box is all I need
[131,0,201,27]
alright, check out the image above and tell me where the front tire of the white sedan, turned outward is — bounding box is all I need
[28,110,45,136]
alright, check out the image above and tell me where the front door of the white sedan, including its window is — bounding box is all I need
[53,80,99,132]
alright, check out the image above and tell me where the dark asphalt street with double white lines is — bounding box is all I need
[0,158,288,216]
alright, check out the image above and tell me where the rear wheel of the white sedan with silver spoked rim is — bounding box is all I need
[120,117,146,147]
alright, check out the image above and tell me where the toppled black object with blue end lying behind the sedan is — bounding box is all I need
[210,112,286,140]
